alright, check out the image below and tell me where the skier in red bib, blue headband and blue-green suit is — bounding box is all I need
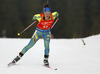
[10,4,59,66]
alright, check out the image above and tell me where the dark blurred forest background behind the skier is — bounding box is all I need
[0,0,100,38]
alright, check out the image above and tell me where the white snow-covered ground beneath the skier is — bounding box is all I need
[0,35,100,74]
